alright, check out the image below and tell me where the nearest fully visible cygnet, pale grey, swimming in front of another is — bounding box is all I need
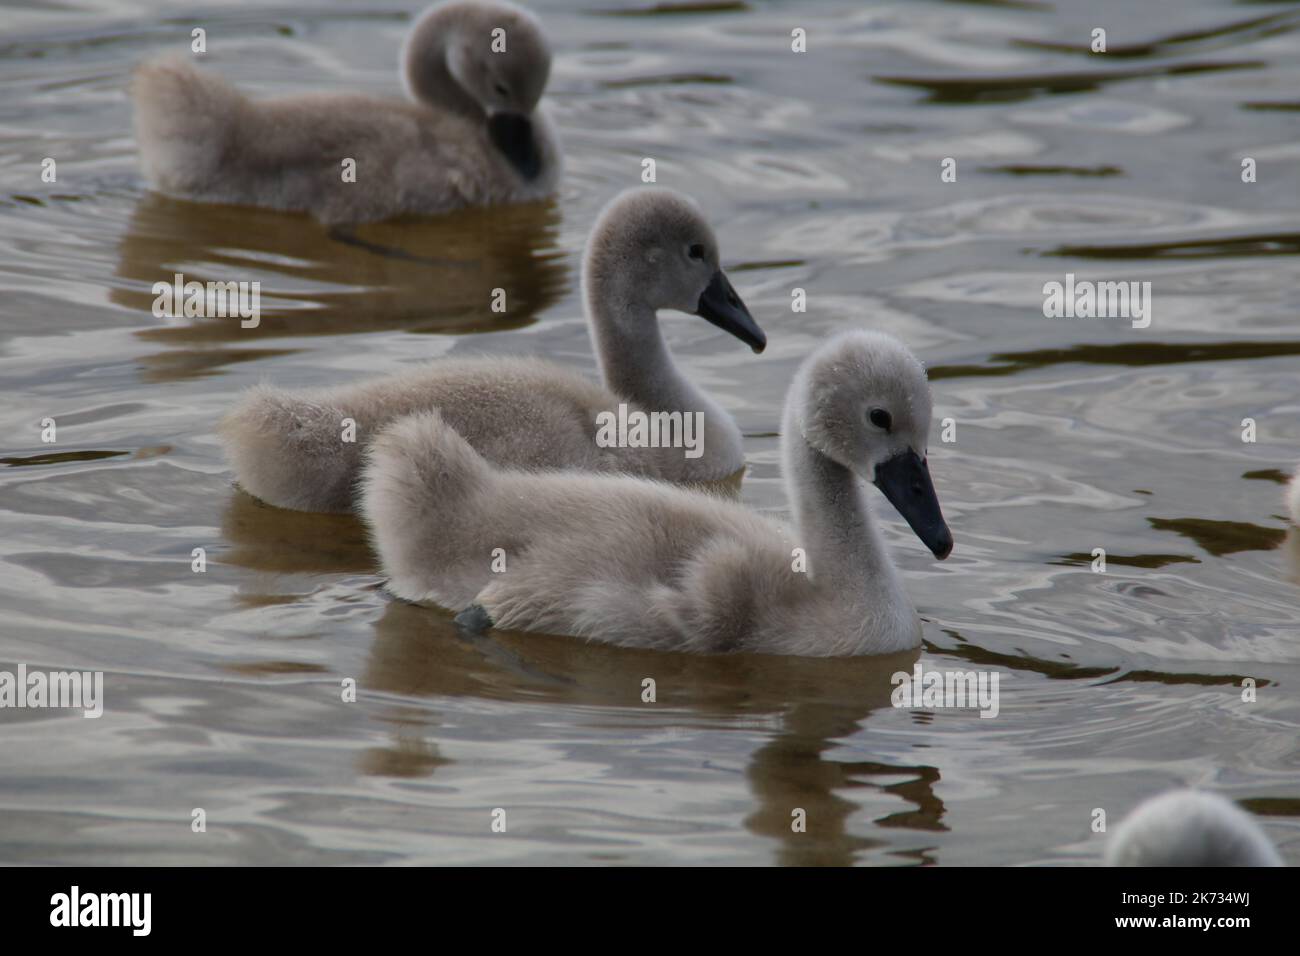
[360,332,953,657]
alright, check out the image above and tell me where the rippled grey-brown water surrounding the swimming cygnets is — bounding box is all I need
[0,0,1300,865]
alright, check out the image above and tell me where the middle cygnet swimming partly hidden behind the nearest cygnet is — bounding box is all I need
[218,187,767,511]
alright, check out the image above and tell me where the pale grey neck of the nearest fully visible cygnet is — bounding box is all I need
[781,403,910,600]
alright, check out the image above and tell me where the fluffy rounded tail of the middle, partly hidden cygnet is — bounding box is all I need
[217,385,367,511]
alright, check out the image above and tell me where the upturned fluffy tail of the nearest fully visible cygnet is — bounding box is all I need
[358,410,497,607]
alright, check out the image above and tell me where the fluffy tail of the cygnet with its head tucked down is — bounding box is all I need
[131,56,248,193]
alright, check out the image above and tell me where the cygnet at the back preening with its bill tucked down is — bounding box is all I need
[133,0,560,224]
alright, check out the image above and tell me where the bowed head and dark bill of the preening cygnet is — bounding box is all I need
[403,0,551,178]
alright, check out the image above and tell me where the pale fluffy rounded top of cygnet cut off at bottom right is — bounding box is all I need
[1106,790,1284,866]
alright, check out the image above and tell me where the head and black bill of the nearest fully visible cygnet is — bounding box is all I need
[788,330,953,559]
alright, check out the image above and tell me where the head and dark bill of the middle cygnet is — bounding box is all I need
[582,187,767,352]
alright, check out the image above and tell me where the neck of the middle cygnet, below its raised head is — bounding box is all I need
[584,268,744,467]
